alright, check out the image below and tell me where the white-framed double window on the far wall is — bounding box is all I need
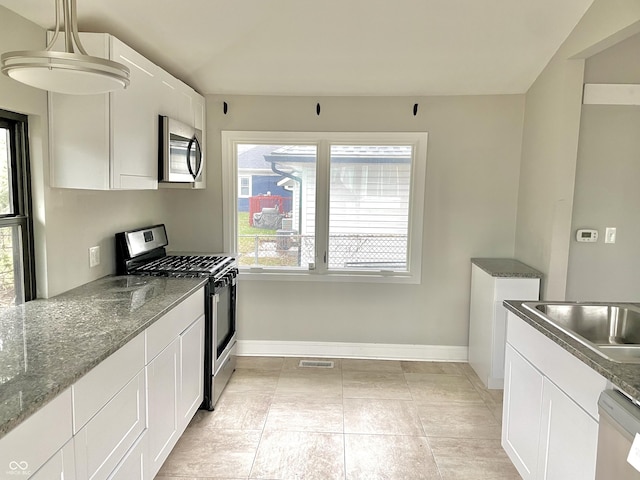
[222,132,427,283]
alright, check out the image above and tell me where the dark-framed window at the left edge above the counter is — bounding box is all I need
[0,110,35,306]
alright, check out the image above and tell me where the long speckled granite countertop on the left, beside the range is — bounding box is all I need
[0,276,206,438]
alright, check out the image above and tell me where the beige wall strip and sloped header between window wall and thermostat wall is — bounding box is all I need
[515,0,640,300]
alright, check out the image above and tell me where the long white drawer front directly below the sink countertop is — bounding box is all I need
[507,313,607,419]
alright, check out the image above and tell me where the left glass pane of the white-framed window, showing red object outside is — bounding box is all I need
[236,144,317,269]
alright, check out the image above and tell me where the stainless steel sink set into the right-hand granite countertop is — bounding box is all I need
[523,302,640,363]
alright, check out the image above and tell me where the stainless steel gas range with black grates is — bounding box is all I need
[116,225,238,410]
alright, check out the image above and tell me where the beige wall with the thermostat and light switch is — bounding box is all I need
[567,35,640,302]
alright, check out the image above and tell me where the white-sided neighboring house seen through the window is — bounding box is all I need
[264,145,412,268]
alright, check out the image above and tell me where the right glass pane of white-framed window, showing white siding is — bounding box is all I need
[328,145,412,271]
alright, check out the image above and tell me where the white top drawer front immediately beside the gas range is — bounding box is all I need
[146,288,204,364]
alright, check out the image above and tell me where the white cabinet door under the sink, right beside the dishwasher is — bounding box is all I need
[538,378,598,480]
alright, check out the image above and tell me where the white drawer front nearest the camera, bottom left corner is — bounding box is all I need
[0,389,71,478]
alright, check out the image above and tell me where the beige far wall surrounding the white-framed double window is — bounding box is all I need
[168,95,523,346]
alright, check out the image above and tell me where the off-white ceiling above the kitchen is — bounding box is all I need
[0,0,593,96]
